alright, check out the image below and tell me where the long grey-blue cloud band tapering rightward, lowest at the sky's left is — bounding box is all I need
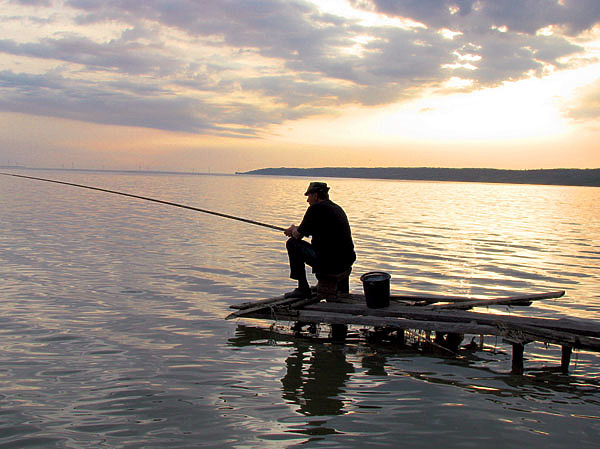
[0,66,332,137]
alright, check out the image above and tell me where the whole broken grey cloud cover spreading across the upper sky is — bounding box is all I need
[0,0,600,137]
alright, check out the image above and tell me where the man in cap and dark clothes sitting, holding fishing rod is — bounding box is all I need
[284,182,356,298]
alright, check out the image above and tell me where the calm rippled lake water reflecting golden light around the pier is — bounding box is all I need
[0,170,600,448]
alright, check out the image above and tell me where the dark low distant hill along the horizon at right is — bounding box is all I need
[236,167,600,187]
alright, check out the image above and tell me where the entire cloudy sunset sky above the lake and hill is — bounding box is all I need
[0,0,600,173]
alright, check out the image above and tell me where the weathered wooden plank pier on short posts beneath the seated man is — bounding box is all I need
[227,291,600,374]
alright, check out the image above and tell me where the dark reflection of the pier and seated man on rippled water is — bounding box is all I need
[229,325,600,402]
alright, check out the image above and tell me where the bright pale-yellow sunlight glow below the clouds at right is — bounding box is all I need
[278,55,600,152]
